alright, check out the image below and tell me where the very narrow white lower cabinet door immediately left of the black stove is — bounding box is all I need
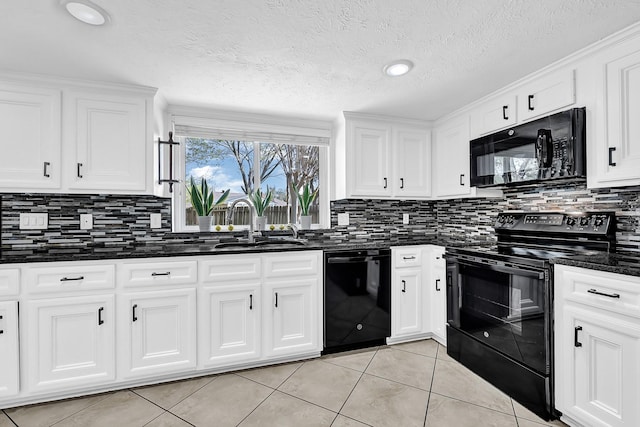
[429,247,447,346]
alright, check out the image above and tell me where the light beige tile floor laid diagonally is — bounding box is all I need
[0,340,564,427]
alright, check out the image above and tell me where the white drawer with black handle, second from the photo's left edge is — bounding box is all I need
[24,264,115,294]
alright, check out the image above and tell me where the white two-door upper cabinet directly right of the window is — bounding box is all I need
[345,113,431,199]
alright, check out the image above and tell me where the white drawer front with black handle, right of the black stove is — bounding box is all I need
[555,266,640,317]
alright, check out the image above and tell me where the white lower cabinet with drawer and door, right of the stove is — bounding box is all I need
[554,266,640,427]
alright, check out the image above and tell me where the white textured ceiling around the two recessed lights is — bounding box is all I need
[0,0,640,119]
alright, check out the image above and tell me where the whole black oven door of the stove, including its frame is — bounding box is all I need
[447,259,550,374]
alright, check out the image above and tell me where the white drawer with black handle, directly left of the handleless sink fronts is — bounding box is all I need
[118,261,198,287]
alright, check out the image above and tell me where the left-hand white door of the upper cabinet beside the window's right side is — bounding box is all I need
[347,121,393,197]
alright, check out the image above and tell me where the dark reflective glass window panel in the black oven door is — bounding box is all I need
[459,264,548,373]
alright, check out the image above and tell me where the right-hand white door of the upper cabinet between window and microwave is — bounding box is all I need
[390,128,431,198]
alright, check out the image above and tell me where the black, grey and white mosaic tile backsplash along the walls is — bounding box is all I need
[0,183,640,254]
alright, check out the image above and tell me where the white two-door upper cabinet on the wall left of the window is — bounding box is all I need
[0,76,155,194]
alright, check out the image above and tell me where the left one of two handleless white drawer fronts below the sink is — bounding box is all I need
[200,255,261,285]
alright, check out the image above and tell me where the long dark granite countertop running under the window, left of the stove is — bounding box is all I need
[0,236,476,264]
